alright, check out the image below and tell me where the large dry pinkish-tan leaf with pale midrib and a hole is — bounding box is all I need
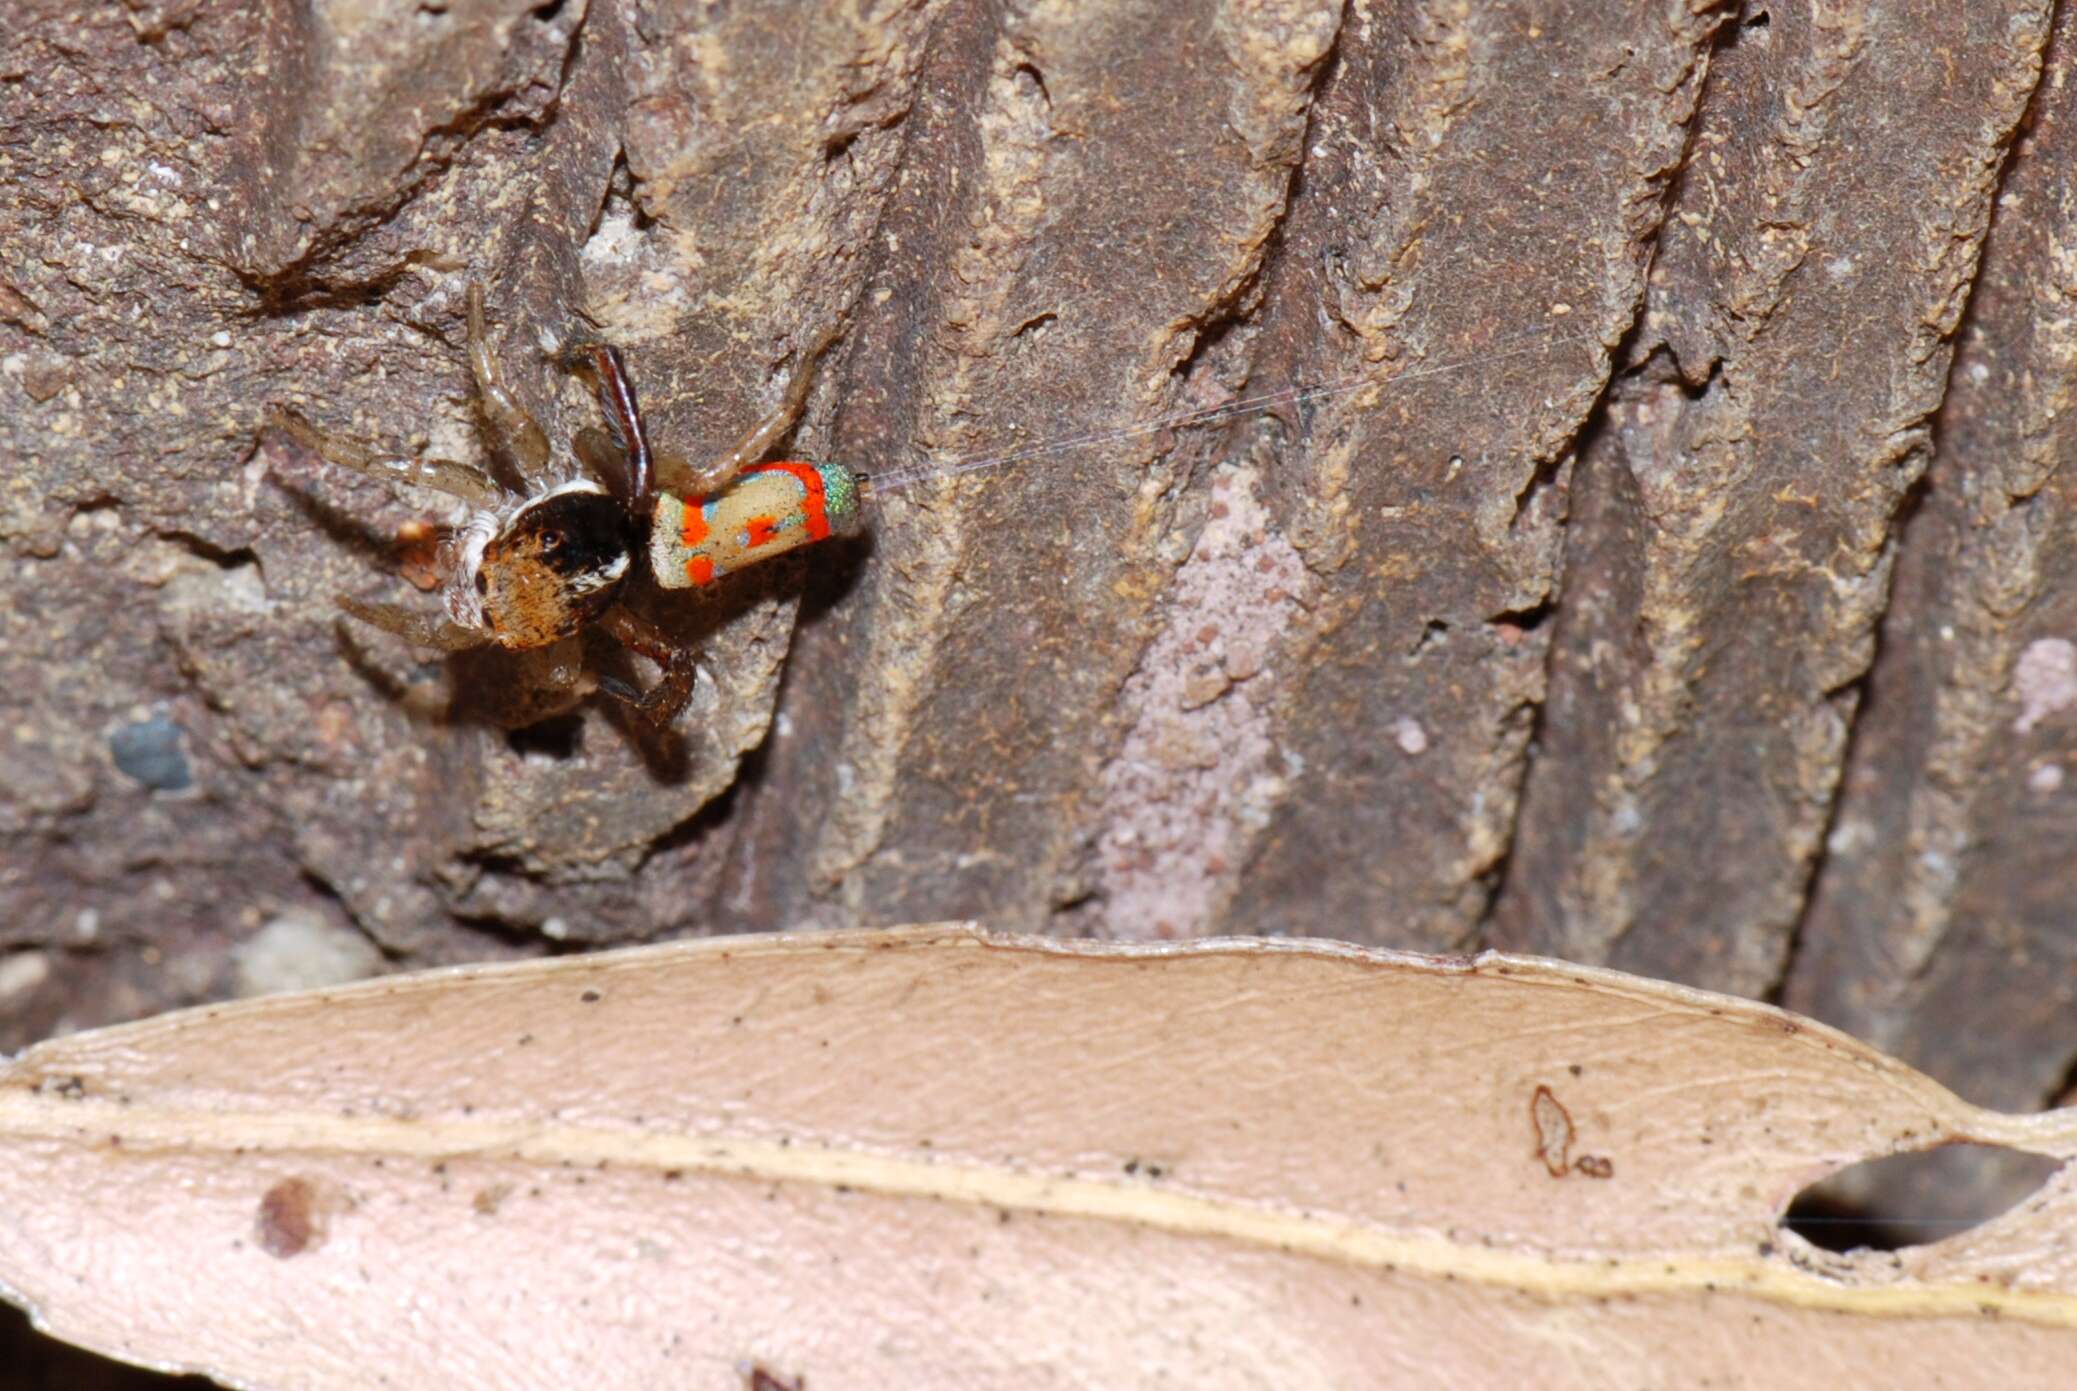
[0,928,2077,1391]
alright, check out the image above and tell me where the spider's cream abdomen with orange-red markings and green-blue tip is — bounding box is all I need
[650,461,860,590]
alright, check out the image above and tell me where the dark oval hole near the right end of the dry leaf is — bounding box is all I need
[1782,1144,2060,1252]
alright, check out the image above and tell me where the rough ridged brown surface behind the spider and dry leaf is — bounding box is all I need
[0,0,2077,1378]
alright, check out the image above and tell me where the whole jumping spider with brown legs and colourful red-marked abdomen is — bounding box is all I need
[274,284,862,722]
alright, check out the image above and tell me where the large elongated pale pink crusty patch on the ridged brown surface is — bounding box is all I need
[1093,467,1309,938]
